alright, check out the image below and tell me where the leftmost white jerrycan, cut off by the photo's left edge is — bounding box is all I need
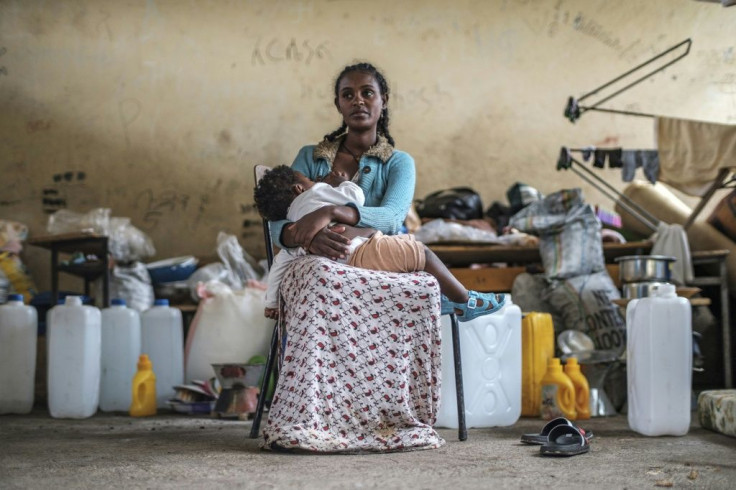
[0,294,38,414]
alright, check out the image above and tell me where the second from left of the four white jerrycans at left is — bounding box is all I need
[46,296,102,418]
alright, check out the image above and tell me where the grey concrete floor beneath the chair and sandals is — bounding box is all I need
[0,409,736,490]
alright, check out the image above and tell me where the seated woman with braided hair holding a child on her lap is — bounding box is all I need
[263,63,498,452]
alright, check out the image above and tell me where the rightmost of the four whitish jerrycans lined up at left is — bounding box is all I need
[141,299,184,408]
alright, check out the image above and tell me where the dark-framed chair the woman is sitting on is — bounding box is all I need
[250,165,468,441]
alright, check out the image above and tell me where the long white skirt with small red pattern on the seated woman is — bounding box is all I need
[263,256,444,453]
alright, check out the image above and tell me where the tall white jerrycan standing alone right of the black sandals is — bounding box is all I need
[626,284,693,436]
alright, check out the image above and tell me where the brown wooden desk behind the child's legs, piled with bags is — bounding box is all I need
[427,241,652,292]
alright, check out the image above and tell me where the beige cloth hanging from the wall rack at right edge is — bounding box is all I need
[654,117,736,197]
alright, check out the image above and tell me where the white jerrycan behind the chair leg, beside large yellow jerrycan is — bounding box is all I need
[435,294,521,429]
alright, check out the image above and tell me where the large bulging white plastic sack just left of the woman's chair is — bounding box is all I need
[184,281,273,379]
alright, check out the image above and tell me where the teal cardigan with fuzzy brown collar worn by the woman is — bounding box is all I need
[271,136,416,248]
